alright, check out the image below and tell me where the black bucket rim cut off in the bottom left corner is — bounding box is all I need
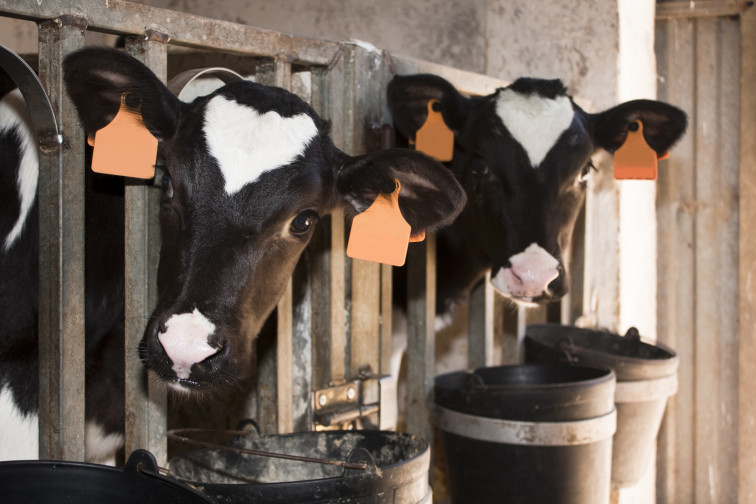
[0,450,212,504]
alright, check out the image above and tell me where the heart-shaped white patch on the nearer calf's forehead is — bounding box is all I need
[203,96,318,194]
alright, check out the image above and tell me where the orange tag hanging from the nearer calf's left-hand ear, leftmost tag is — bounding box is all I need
[90,93,158,179]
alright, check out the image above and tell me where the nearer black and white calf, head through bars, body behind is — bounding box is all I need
[0,48,465,460]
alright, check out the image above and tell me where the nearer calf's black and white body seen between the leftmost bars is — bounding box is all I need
[0,72,124,462]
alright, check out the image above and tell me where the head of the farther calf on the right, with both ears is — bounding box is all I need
[388,75,687,302]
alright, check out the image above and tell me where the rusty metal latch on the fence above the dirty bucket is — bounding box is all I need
[313,375,397,430]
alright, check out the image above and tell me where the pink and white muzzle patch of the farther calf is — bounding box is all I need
[491,243,559,301]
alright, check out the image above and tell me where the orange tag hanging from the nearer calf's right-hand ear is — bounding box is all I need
[346,179,425,266]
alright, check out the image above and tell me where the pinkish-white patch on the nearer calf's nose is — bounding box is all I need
[158,308,218,380]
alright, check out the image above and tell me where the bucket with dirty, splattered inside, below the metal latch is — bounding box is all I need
[170,430,432,504]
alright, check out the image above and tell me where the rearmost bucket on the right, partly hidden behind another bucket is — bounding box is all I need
[525,324,678,488]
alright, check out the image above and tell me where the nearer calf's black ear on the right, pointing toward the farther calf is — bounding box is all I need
[336,149,467,234]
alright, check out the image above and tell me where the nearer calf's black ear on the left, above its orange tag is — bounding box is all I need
[63,47,181,140]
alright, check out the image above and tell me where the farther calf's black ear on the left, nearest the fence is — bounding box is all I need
[388,74,471,139]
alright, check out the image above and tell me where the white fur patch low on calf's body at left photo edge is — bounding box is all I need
[0,388,39,461]
